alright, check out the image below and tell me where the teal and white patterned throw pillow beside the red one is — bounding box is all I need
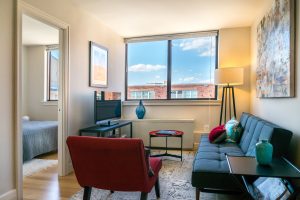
[225,118,243,143]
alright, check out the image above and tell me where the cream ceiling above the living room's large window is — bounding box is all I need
[72,0,273,37]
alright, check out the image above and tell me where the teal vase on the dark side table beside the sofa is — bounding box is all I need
[256,140,273,165]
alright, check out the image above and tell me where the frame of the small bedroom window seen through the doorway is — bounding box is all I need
[45,46,59,102]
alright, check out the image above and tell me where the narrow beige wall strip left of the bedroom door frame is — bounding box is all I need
[0,0,15,199]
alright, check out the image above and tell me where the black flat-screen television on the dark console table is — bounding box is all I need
[94,92,121,125]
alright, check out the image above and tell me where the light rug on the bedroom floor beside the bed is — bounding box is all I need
[23,159,58,176]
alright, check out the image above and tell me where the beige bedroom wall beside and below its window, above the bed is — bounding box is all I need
[22,46,58,120]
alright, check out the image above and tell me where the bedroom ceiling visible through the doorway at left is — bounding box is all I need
[22,15,59,45]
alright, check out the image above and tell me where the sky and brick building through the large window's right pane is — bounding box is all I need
[171,37,216,99]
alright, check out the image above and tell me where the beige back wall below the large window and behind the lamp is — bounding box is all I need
[123,27,251,138]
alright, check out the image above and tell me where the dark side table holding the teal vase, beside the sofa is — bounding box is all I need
[226,155,300,199]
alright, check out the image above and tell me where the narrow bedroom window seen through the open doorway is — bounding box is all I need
[46,48,59,101]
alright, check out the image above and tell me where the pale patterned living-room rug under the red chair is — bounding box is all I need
[70,151,238,200]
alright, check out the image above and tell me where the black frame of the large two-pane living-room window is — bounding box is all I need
[125,30,219,101]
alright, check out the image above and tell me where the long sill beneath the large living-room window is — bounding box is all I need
[123,100,221,106]
